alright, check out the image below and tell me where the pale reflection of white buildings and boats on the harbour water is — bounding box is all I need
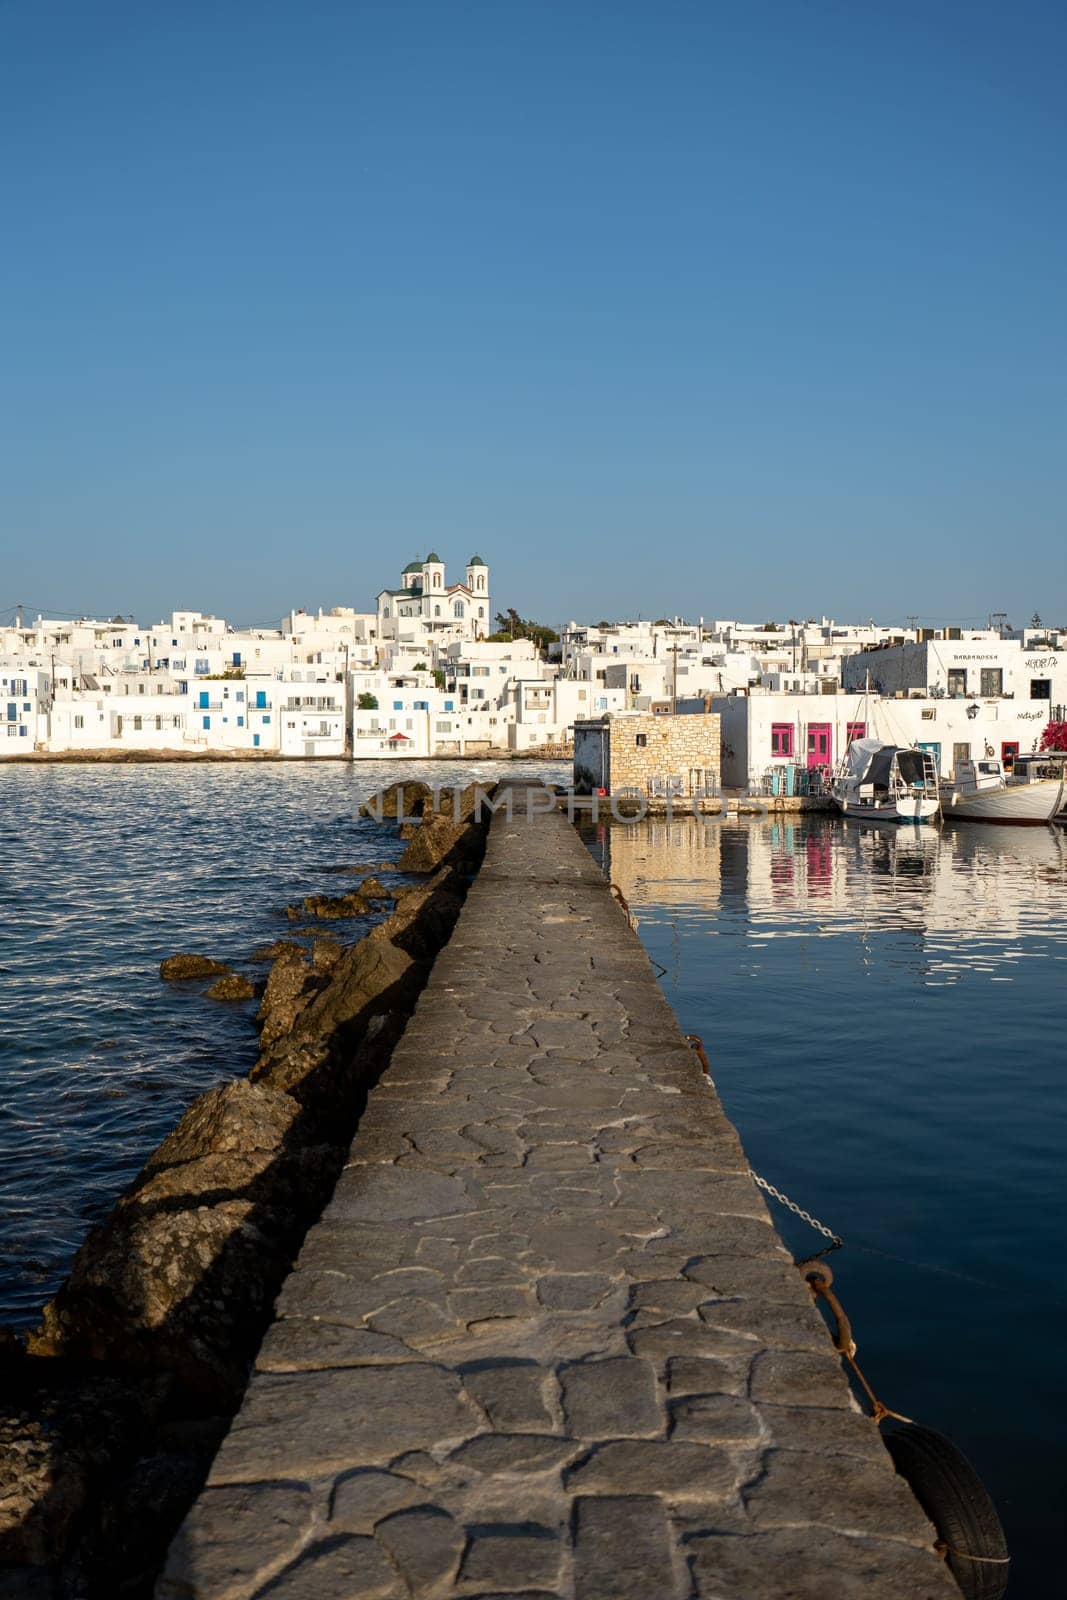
[585,816,1067,982]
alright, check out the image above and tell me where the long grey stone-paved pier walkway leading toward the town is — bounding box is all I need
[157,795,958,1600]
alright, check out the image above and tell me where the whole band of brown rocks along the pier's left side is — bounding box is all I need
[0,786,488,1600]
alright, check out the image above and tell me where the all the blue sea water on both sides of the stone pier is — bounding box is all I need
[0,763,1067,1600]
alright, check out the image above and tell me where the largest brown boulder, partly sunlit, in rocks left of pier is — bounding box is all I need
[29,1082,341,1405]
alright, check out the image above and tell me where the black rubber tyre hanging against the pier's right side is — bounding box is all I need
[881,1422,1011,1600]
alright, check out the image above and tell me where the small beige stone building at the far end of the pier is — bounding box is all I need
[574,710,720,797]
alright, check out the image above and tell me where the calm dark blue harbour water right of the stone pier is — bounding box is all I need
[584,816,1067,1600]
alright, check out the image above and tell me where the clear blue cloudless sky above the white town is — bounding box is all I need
[0,0,1067,622]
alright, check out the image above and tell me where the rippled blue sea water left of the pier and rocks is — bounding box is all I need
[0,762,558,1325]
